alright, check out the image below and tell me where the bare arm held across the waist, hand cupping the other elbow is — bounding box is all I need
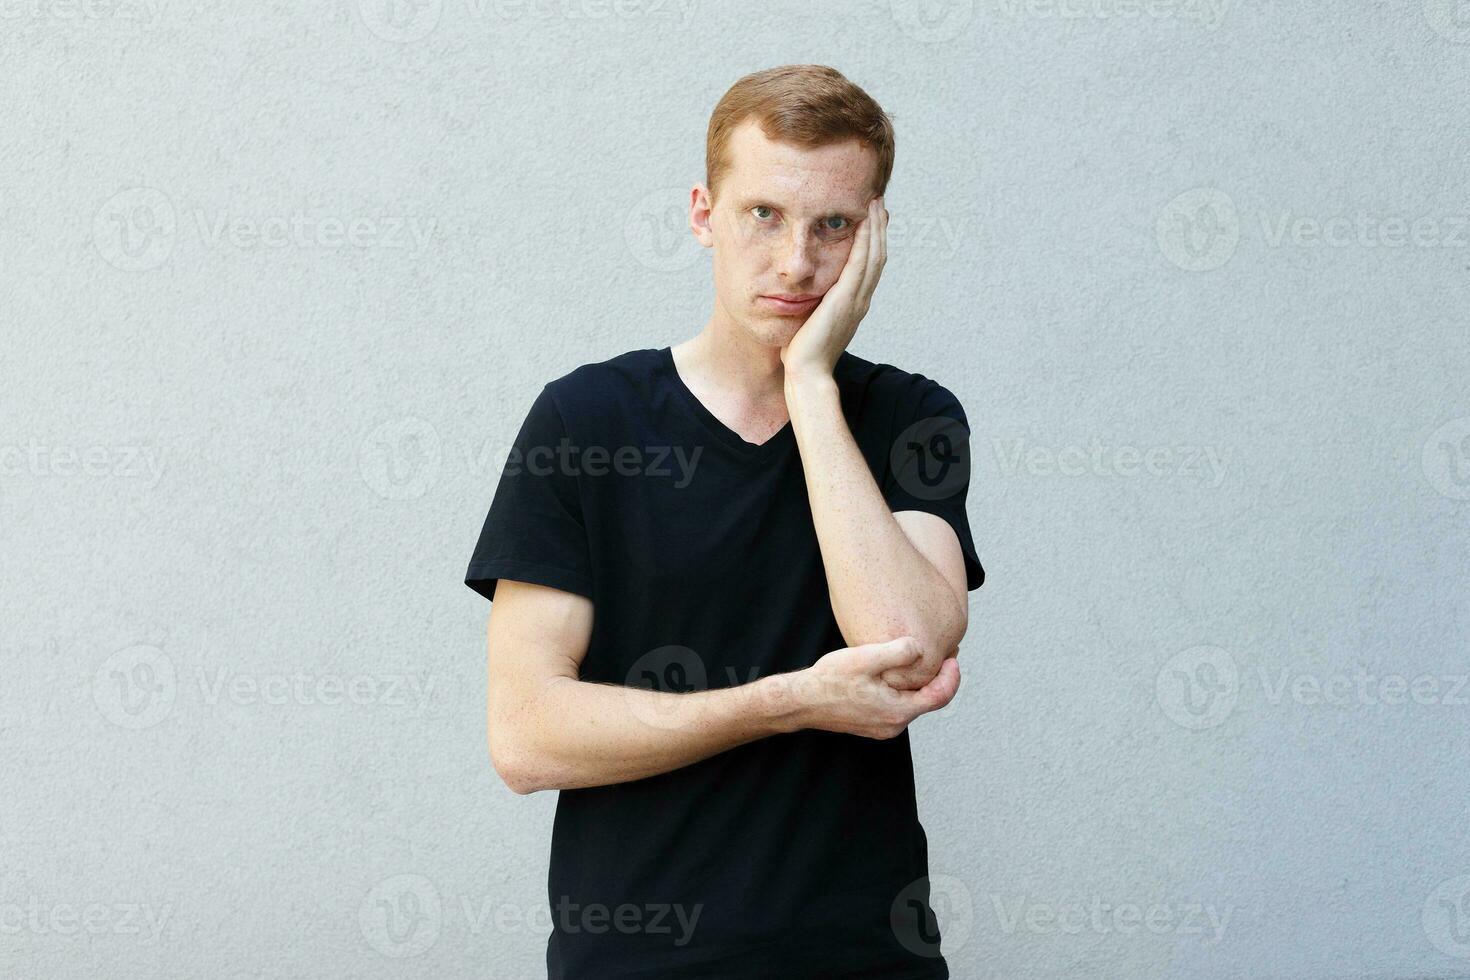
[487,579,960,793]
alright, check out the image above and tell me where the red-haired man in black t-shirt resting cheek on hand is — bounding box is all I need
[465,65,985,980]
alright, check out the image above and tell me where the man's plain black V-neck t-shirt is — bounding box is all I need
[465,347,985,980]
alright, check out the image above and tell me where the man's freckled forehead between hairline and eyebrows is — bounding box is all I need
[725,119,878,213]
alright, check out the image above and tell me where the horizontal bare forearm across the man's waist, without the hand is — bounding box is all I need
[513,674,800,792]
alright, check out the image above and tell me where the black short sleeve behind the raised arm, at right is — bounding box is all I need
[882,376,985,592]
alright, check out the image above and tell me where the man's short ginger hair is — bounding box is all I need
[704,65,894,198]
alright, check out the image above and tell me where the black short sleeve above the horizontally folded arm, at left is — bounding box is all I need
[465,386,592,599]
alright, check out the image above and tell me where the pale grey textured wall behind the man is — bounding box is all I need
[0,0,1470,980]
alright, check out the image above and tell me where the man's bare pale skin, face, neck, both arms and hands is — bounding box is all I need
[487,123,969,793]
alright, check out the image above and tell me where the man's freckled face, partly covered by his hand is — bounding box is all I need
[695,119,878,347]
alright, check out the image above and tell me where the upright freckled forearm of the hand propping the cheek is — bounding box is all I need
[786,375,966,651]
